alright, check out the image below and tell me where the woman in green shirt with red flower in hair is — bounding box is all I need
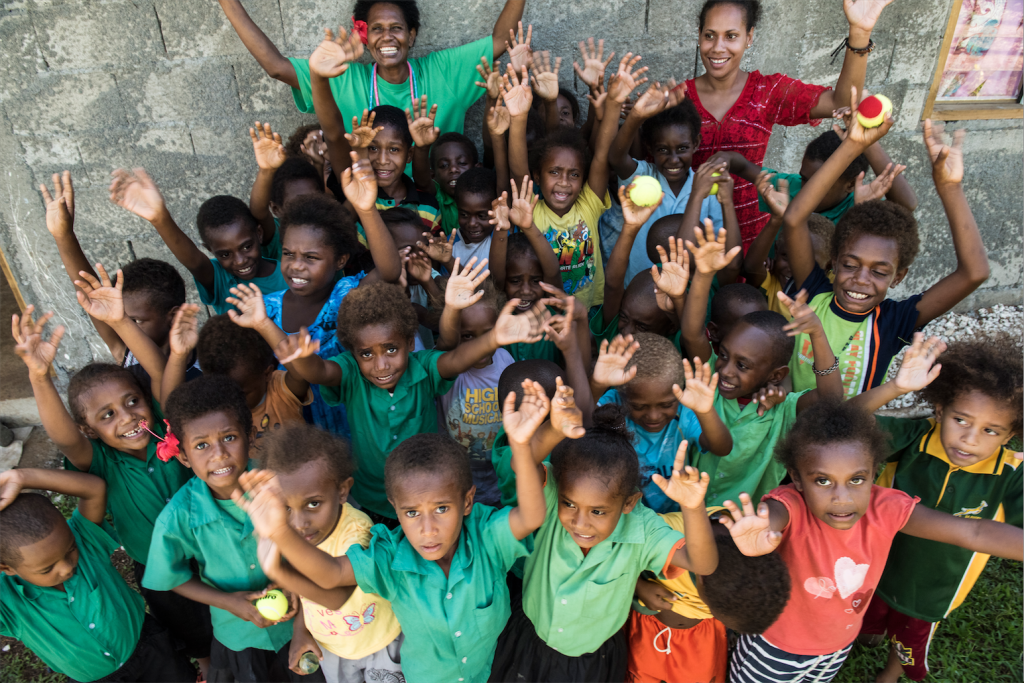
[220,0,530,133]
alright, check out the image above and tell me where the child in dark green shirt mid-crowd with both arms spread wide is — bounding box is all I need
[264,283,544,524]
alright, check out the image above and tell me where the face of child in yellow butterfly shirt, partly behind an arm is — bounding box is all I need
[275,460,353,546]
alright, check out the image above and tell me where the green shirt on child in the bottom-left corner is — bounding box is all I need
[0,510,145,681]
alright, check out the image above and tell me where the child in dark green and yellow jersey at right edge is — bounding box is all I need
[851,333,1024,683]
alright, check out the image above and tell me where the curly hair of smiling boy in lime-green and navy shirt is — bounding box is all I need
[831,200,921,269]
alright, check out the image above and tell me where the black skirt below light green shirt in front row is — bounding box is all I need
[490,605,629,683]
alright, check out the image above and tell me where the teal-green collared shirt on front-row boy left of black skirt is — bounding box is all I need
[348,504,528,683]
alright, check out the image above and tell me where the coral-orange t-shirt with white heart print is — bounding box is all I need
[762,484,921,655]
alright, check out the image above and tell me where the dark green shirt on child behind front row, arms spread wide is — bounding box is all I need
[321,351,454,519]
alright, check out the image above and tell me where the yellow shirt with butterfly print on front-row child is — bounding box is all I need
[302,503,401,659]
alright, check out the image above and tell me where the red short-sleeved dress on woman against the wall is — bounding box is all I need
[686,71,831,252]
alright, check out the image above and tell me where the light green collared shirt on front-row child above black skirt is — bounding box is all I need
[522,468,683,657]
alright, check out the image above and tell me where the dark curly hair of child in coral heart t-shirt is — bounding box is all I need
[775,401,889,472]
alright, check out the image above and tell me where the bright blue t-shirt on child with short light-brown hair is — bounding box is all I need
[597,389,703,514]
